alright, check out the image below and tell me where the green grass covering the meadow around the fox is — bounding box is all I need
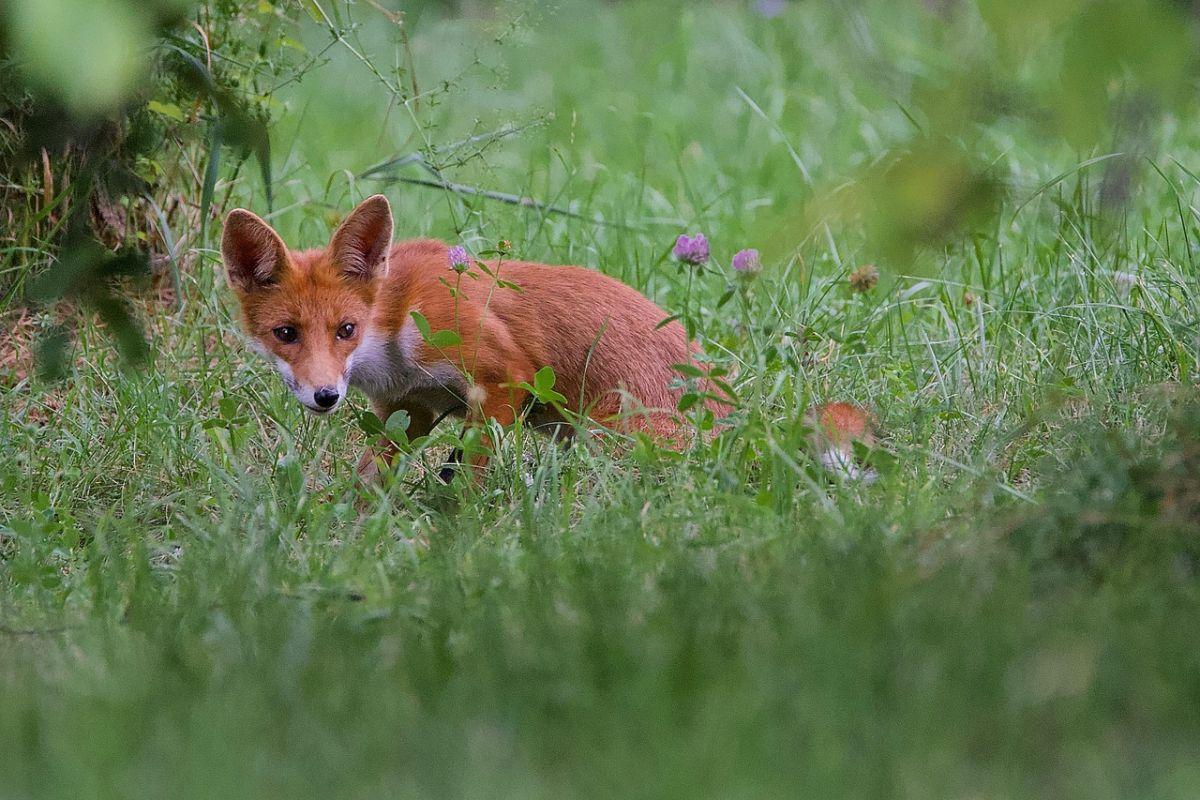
[0,2,1200,799]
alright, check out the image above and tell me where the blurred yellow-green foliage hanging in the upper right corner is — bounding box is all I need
[808,0,1200,269]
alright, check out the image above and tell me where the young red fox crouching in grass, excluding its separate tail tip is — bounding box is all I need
[221,194,730,473]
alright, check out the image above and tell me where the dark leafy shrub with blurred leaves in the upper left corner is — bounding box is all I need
[0,0,304,373]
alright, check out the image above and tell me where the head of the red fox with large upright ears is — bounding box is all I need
[221,194,391,414]
